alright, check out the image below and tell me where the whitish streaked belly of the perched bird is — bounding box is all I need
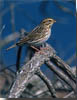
[28,32,51,46]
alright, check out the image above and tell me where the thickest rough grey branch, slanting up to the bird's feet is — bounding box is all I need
[9,43,55,98]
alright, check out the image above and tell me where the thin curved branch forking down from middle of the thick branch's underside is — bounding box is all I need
[36,69,58,98]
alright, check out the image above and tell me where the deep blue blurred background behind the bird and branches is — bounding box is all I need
[0,0,76,71]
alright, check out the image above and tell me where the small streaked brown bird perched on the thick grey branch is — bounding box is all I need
[7,18,56,51]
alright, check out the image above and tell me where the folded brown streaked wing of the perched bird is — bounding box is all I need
[17,26,47,45]
